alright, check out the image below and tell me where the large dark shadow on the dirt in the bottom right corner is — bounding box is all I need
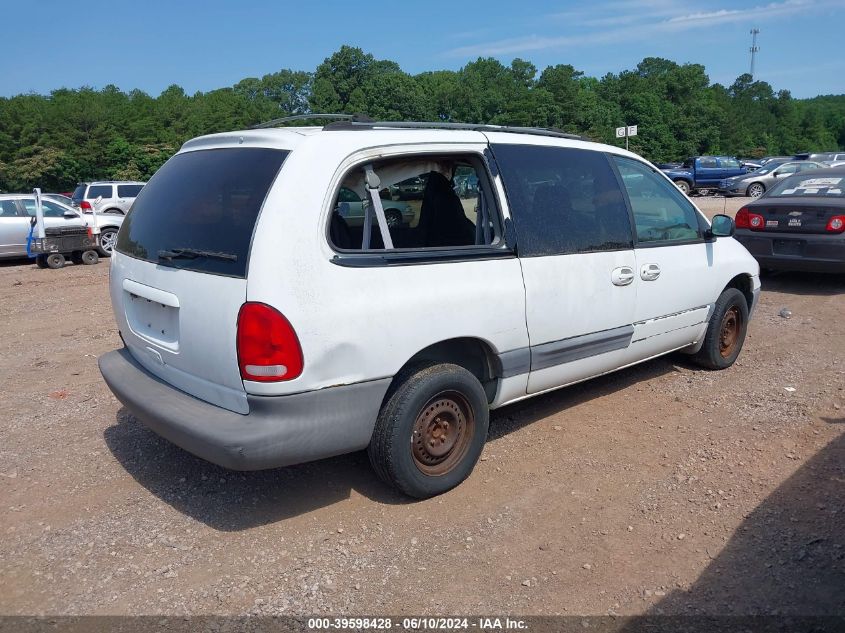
[623,432,845,630]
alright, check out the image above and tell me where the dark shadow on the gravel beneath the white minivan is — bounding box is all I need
[103,359,677,531]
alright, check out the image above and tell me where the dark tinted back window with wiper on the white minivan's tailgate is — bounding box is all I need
[117,148,289,277]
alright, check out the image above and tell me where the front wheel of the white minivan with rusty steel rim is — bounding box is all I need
[692,288,748,369]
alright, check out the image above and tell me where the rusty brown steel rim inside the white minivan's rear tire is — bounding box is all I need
[411,391,475,477]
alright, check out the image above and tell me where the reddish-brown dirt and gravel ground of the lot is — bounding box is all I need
[0,198,845,615]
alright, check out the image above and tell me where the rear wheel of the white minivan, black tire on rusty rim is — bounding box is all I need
[367,364,490,499]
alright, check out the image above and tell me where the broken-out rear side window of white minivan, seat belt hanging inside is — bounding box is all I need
[329,155,501,250]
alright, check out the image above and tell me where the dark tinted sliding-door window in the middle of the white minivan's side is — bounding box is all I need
[493,144,632,257]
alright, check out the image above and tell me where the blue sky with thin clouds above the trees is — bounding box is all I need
[0,0,845,97]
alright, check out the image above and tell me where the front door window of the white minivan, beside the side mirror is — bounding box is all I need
[613,156,700,242]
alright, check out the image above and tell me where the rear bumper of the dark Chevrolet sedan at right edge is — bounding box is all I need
[734,230,845,273]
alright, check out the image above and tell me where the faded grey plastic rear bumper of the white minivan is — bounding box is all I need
[99,349,390,470]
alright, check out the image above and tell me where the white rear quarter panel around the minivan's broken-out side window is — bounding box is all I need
[245,131,528,395]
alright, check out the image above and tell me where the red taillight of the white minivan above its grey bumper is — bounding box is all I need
[237,302,302,382]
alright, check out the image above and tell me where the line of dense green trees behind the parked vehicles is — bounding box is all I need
[0,46,845,191]
